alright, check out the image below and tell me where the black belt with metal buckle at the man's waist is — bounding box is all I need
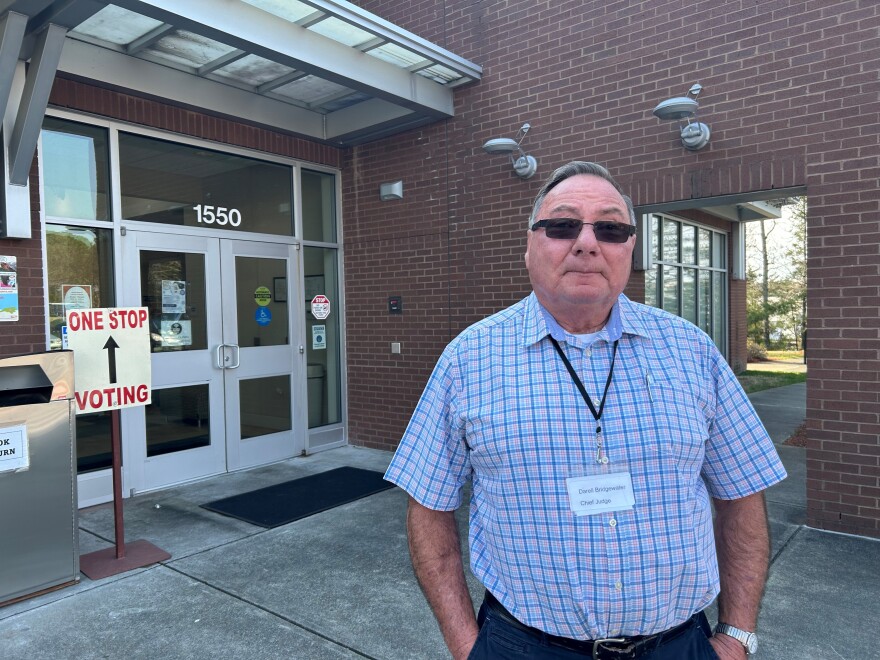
[484,591,700,660]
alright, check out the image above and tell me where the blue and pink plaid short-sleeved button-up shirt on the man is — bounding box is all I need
[385,294,786,639]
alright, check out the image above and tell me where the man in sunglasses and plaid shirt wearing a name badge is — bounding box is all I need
[386,162,786,660]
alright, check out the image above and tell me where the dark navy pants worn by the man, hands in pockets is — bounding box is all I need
[468,602,718,660]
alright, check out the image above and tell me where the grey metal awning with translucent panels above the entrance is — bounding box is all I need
[0,0,482,146]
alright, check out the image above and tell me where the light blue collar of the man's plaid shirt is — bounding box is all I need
[523,292,648,348]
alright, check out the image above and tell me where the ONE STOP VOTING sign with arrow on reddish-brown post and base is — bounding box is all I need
[67,307,171,580]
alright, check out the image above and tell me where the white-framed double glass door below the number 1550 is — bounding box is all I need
[123,230,307,492]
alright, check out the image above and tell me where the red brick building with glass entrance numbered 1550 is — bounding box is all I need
[0,0,880,536]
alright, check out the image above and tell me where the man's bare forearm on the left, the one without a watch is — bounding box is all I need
[406,497,479,660]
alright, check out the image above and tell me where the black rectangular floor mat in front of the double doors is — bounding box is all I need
[202,467,394,527]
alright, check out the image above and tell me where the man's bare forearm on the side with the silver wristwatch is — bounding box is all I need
[712,493,770,660]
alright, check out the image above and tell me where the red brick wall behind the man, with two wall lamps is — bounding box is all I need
[344,0,880,536]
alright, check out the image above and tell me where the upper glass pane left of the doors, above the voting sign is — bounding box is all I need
[41,117,110,220]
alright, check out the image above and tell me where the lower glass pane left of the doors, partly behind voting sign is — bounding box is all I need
[46,225,115,473]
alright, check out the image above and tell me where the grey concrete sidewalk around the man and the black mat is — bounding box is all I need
[0,378,880,660]
